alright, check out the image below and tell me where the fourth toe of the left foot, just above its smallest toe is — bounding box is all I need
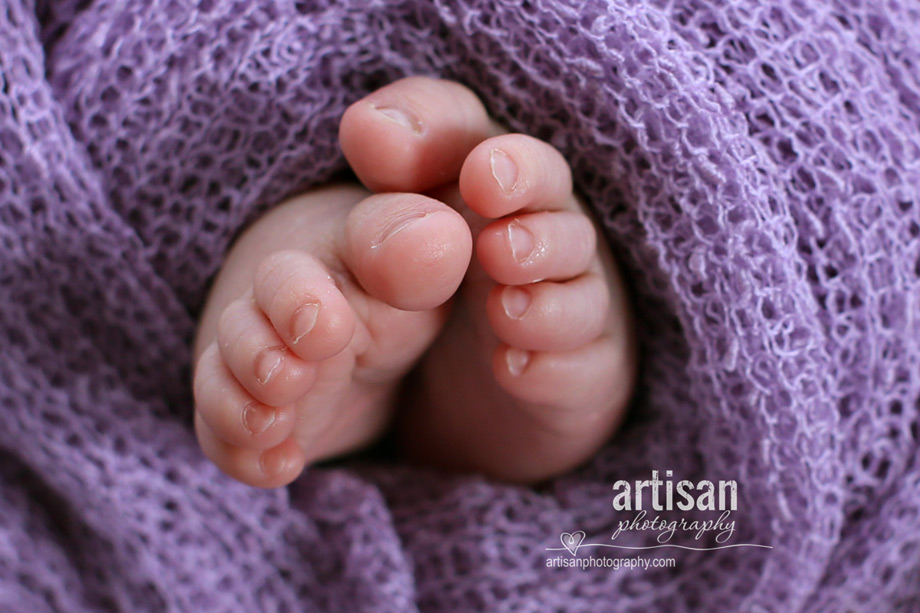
[194,343,295,449]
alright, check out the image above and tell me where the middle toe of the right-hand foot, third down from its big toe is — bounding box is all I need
[476,211,597,285]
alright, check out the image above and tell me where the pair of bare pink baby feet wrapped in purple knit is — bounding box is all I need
[194,77,636,488]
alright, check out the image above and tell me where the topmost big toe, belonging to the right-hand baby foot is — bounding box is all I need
[339,77,500,192]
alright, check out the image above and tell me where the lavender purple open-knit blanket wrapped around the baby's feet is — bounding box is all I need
[0,0,920,613]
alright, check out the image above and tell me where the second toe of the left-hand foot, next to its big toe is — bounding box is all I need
[253,250,355,362]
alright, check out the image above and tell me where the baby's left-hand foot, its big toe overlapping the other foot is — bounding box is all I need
[194,182,472,487]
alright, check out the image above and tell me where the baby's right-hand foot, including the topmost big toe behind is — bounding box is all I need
[341,81,637,482]
